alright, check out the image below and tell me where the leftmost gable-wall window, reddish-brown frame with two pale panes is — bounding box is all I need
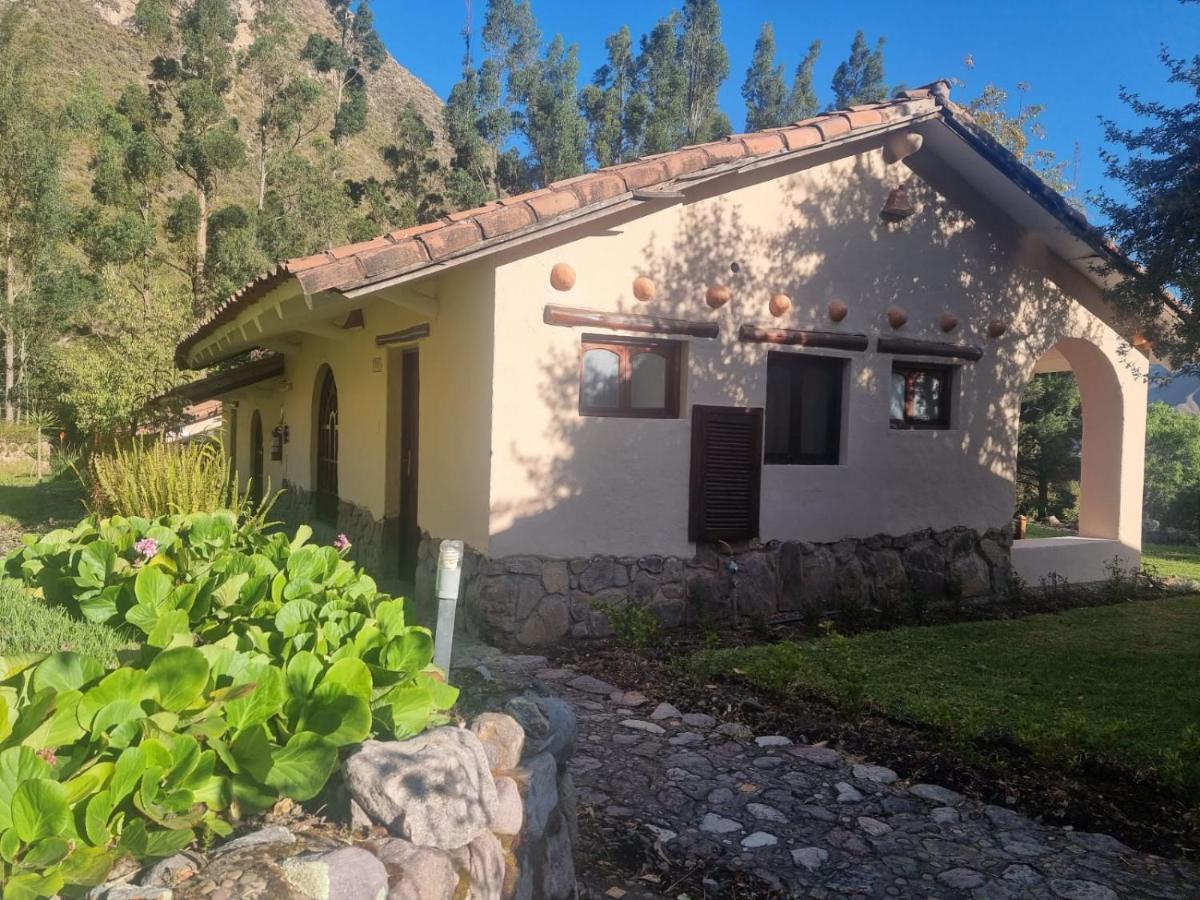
[580,335,682,419]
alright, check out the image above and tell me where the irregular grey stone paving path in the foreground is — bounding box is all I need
[460,643,1200,900]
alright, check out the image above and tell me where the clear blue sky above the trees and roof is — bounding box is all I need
[373,0,1200,216]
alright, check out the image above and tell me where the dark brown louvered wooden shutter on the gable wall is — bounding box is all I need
[688,407,762,542]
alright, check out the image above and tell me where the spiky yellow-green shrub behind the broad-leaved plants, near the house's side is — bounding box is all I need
[88,439,238,518]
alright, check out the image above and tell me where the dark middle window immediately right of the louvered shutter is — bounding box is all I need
[764,350,846,466]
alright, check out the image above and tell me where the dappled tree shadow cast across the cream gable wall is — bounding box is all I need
[493,146,1123,557]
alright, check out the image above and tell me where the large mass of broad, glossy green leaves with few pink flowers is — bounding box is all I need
[0,511,457,900]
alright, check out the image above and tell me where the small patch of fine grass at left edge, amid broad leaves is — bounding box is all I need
[0,581,132,666]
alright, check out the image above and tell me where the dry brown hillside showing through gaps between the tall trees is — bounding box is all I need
[25,0,443,199]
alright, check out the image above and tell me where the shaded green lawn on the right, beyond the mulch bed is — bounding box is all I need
[685,595,1200,790]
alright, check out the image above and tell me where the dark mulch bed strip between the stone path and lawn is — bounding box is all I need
[553,630,1200,859]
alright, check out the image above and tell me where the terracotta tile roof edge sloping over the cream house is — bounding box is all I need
[176,82,1123,367]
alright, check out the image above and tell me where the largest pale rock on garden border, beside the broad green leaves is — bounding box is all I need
[343,726,498,850]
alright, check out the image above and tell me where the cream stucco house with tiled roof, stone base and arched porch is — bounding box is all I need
[178,83,1148,644]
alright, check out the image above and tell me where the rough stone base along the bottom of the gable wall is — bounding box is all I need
[416,527,1013,647]
